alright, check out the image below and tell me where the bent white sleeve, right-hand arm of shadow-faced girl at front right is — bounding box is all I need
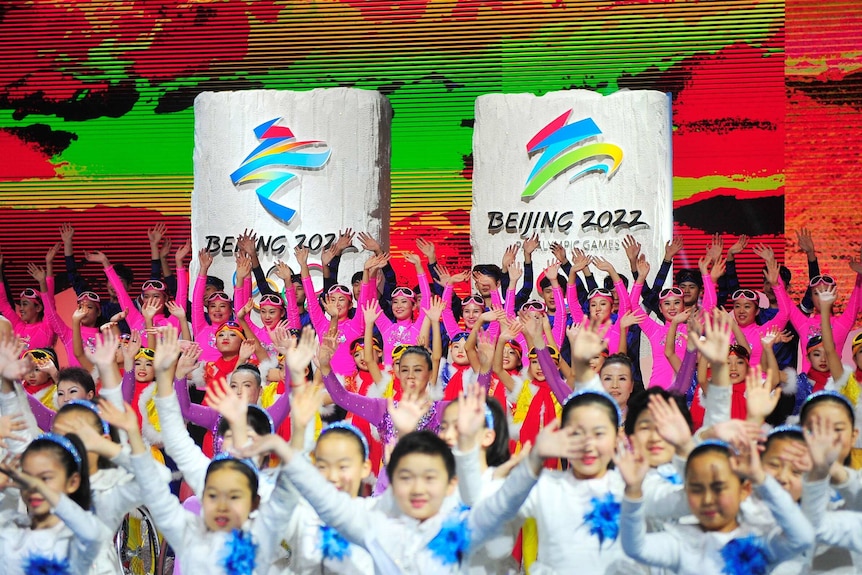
[754,475,814,562]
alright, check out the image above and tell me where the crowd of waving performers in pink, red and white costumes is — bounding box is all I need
[0,224,862,575]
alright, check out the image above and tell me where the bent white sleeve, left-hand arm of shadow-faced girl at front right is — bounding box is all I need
[620,497,682,572]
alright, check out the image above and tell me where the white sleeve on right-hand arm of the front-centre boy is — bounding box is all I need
[467,458,538,551]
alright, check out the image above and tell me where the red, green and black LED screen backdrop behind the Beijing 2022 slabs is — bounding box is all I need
[0,0,862,308]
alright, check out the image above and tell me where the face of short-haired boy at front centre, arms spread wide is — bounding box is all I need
[391,453,455,521]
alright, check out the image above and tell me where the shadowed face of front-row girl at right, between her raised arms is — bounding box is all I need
[685,452,751,533]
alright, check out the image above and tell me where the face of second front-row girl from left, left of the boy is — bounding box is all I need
[201,467,257,531]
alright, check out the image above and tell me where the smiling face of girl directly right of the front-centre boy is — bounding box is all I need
[565,404,617,479]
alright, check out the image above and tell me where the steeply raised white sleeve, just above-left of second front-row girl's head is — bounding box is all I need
[153,394,210,496]
